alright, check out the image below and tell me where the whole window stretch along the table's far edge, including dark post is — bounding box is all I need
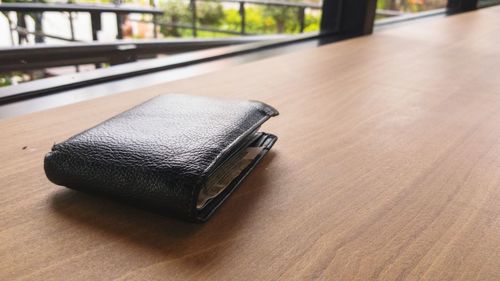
[0,0,500,93]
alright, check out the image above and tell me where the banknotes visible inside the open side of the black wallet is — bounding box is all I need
[196,131,264,210]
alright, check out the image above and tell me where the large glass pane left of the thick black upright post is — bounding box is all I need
[0,0,322,86]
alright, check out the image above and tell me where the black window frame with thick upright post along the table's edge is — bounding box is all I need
[0,0,499,105]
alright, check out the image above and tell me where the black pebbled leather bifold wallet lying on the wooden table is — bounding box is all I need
[44,94,278,221]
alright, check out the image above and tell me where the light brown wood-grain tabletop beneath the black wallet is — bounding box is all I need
[0,4,500,280]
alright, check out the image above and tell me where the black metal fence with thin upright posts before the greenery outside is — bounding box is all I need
[0,0,404,45]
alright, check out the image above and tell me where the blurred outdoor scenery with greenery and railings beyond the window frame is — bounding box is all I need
[0,0,447,86]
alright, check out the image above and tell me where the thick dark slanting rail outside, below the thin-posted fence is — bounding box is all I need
[0,35,288,73]
